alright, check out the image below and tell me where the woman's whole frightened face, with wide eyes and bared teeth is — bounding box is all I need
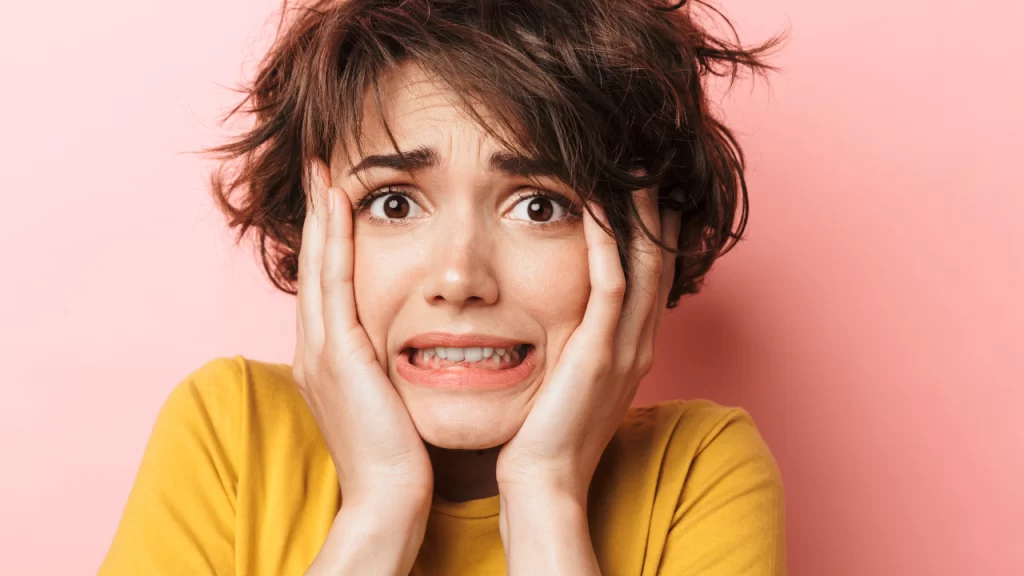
[331,66,590,449]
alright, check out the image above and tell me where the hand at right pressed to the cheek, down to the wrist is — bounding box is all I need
[498,189,679,498]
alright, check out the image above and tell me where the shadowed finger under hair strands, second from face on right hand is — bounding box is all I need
[615,188,662,362]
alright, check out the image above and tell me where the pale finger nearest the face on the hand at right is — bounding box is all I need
[580,204,626,345]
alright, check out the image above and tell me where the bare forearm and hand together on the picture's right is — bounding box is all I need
[496,189,678,576]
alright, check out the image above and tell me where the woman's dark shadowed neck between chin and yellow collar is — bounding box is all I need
[427,444,501,502]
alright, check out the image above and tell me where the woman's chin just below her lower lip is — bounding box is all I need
[402,390,527,450]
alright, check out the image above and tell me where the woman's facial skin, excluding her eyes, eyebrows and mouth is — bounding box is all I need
[331,67,588,449]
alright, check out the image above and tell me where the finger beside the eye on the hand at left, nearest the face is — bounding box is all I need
[321,188,367,352]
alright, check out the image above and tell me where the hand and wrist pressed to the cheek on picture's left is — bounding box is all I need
[292,159,433,574]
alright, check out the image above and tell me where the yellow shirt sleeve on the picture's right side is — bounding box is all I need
[657,410,786,576]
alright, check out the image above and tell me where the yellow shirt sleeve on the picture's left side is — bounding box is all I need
[99,359,243,576]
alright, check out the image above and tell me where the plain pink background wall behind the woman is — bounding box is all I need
[0,0,1024,576]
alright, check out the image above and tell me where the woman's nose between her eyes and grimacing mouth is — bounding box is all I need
[423,218,498,307]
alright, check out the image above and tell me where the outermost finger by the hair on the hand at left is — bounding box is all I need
[297,159,330,349]
